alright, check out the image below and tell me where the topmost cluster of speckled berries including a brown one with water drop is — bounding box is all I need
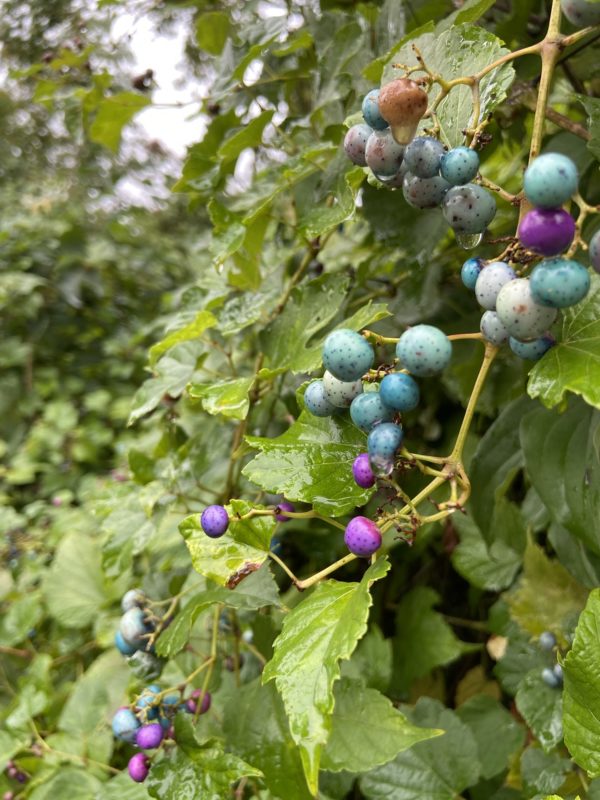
[344,78,496,248]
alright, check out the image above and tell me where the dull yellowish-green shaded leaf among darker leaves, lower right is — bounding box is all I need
[507,542,588,640]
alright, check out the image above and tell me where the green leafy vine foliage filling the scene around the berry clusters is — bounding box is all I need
[0,0,600,800]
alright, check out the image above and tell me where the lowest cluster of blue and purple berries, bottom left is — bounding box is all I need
[112,684,211,783]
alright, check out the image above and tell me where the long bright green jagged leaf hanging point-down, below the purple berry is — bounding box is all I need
[263,559,389,793]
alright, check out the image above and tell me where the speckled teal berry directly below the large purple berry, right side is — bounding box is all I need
[530,258,591,308]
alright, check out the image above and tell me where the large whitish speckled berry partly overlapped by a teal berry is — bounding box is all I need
[496,278,557,342]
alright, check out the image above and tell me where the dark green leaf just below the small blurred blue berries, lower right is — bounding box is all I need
[515,669,563,753]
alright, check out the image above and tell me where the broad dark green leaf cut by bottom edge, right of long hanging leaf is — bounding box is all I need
[360,697,480,800]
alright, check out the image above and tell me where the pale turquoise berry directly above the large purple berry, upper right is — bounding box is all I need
[523,153,578,208]
